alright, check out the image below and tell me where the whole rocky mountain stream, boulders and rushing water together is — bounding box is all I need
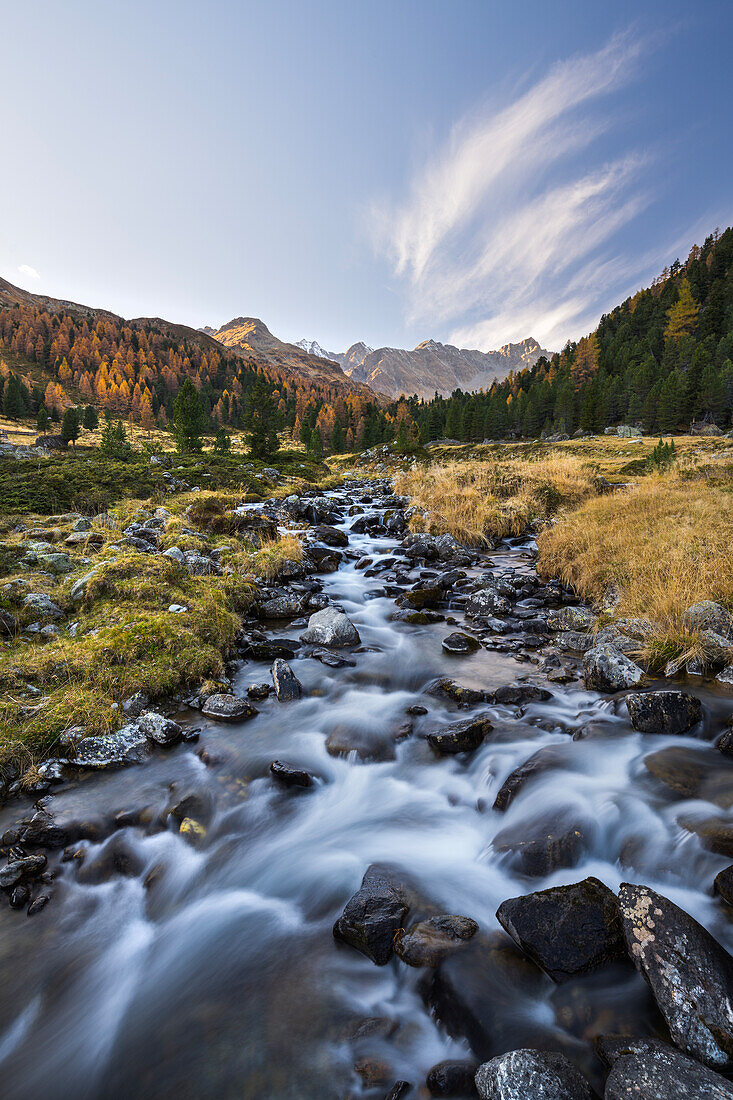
[0,482,733,1100]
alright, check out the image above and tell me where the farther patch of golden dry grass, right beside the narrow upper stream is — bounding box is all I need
[395,453,595,546]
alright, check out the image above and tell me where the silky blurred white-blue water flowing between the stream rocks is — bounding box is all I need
[0,490,733,1100]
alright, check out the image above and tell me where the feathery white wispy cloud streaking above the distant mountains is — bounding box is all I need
[372,32,650,348]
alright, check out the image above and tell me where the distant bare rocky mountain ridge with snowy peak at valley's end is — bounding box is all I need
[290,337,550,399]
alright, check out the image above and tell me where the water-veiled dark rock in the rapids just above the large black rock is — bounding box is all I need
[493,814,587,878]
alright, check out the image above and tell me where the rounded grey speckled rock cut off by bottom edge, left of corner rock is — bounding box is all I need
[475,1049,593,1100]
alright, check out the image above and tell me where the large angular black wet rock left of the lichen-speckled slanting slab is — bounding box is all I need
[496,878,626,982]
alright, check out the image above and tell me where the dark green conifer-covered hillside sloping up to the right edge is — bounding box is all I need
[409,229,733,440]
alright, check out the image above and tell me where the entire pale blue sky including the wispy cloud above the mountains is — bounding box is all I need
[0,0,733,352]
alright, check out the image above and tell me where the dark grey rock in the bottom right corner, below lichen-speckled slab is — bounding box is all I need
[600,1038,733,1100]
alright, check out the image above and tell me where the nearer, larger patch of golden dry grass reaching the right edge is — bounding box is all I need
[537,473,733,647]
